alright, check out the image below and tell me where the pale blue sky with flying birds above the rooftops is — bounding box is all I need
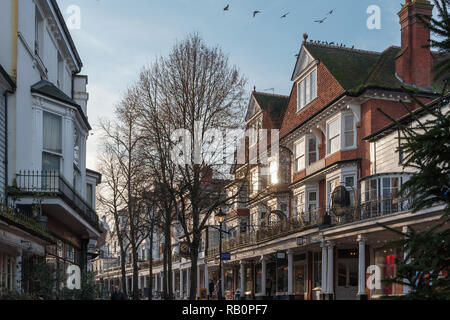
[58,0,418,170]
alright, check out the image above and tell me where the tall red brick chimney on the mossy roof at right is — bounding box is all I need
[395,0,433,89]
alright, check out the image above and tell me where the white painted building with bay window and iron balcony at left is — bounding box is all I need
[0,0,101,296]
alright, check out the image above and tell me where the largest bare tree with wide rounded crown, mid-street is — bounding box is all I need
[136,34,246,299]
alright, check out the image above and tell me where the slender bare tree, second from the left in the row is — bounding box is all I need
[100,88,153,300]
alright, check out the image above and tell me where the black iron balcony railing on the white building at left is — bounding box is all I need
[13,171,99,229]
